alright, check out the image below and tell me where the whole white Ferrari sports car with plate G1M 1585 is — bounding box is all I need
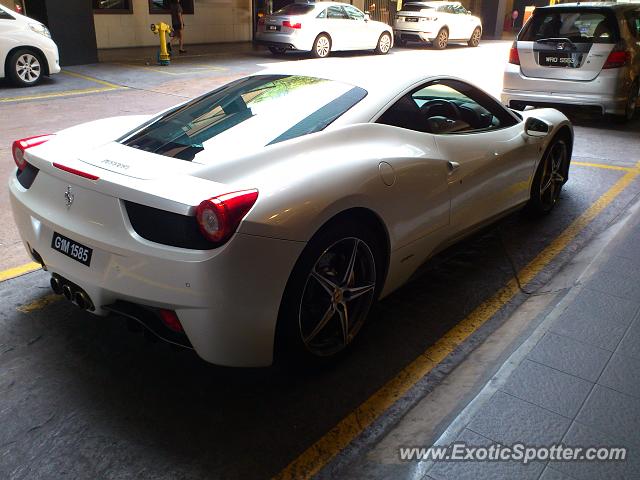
[9,71,573,366]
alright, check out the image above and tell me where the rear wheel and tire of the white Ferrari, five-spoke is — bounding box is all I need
[276,219,383,364]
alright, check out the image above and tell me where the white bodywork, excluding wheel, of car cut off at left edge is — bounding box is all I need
[0,5,60,78]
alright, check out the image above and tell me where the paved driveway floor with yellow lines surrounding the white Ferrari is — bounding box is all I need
[0,42,640,479]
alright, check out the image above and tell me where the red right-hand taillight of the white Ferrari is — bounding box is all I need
[196,189,258,244]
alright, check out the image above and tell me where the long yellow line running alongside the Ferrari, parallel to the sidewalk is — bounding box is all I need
[274,162,640,480]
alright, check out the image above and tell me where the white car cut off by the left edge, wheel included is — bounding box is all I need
[0,5,60,87]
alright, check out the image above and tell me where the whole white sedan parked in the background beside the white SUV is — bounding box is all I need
[255,2,393,58]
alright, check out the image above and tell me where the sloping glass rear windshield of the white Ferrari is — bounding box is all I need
[119,75,367,160]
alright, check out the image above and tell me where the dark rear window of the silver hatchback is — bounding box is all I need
[518,8,619,43]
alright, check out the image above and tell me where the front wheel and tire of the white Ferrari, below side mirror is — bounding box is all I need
[526,138,569,216]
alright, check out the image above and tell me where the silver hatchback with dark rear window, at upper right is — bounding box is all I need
[502,2,640,120]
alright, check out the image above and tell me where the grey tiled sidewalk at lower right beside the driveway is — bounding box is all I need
[413,202,640,480]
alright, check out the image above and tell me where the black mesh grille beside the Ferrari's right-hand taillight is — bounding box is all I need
[124,201,215,250]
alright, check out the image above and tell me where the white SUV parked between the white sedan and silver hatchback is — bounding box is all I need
[393,2,482,50]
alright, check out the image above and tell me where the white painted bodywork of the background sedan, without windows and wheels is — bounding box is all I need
[256,2,393,51]
